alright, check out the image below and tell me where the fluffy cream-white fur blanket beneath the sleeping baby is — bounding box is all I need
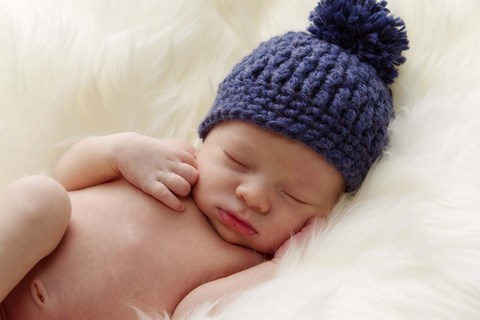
[0,0,480,320]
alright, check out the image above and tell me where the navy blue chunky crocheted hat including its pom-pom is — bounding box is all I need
[199,0,408,191]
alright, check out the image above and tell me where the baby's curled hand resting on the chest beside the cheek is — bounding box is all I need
[116,134,198,211]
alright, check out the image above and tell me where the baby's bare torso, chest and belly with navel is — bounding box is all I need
[5,180,262,320]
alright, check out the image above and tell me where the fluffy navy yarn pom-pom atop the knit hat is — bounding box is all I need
[308,0,408,84]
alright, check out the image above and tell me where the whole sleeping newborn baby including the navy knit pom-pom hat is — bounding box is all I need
[0,0,408,320]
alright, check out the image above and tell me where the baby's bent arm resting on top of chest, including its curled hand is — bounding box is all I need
[55,132,198,210]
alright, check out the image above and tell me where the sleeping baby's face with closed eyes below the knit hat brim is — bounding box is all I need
[193,121,345,253]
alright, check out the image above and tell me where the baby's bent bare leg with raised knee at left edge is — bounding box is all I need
[0,176,70,301]
